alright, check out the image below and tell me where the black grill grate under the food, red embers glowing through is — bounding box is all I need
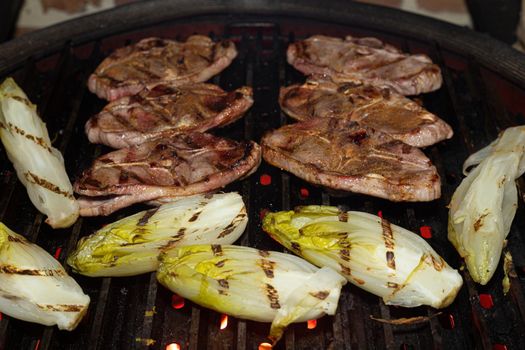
[0,13,525,350]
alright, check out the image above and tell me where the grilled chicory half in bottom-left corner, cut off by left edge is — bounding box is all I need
[0,222,89,331]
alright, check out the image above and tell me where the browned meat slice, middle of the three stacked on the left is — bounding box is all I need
[86,83,253,148]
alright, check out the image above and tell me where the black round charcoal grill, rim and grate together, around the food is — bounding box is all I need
[0,0,525,350]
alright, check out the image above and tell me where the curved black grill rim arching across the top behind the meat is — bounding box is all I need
[0,0,525,87]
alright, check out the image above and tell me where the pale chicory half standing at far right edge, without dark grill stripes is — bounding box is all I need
[448,126,525,284]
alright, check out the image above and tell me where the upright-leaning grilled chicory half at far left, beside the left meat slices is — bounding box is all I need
[0,78,79,228]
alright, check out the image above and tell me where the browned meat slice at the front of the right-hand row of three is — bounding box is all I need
[261,118,441,201]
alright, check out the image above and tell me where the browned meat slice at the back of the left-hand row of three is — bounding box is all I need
[88,35,237,101]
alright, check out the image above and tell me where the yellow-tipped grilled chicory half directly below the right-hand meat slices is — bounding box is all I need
[263,205,463,308]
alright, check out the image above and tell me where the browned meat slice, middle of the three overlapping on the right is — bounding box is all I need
[279,81,452,147]
